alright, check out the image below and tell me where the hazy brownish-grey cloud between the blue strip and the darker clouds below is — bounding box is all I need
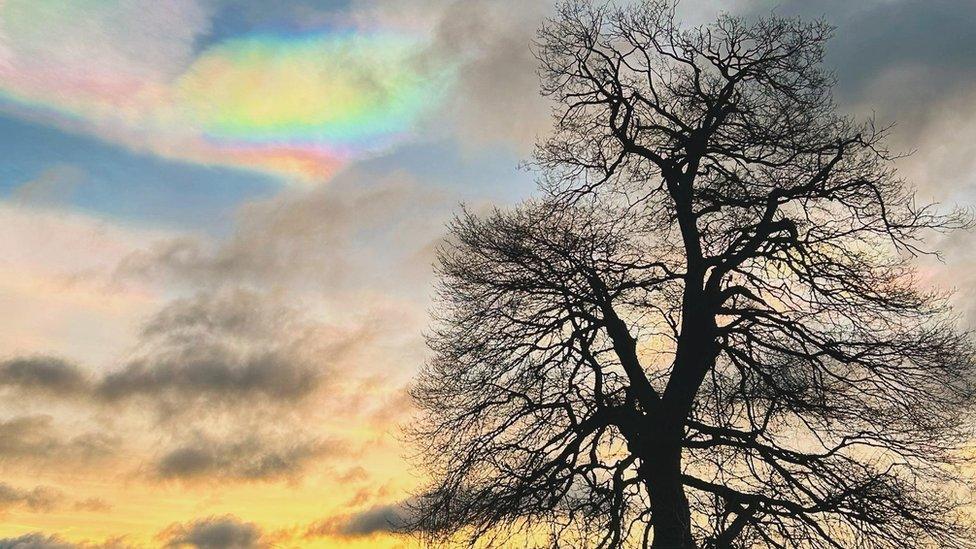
[116,170,454,296]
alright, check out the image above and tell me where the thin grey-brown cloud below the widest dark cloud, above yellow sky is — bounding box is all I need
[154,435,341,481]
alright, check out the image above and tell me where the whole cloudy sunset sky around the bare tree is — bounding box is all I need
[0,0,976,548]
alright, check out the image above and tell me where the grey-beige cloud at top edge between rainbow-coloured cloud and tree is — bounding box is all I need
[334,0,552,150]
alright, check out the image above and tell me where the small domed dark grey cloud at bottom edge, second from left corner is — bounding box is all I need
[159,515,268,549]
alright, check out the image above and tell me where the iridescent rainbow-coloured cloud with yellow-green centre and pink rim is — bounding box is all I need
[0,0,450,181]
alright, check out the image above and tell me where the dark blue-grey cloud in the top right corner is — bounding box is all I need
[739,0,976,133]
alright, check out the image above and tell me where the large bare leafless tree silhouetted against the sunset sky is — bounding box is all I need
[413,1,976,548]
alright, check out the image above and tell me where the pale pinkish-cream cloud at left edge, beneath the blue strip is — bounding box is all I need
[0,201,171,364]
